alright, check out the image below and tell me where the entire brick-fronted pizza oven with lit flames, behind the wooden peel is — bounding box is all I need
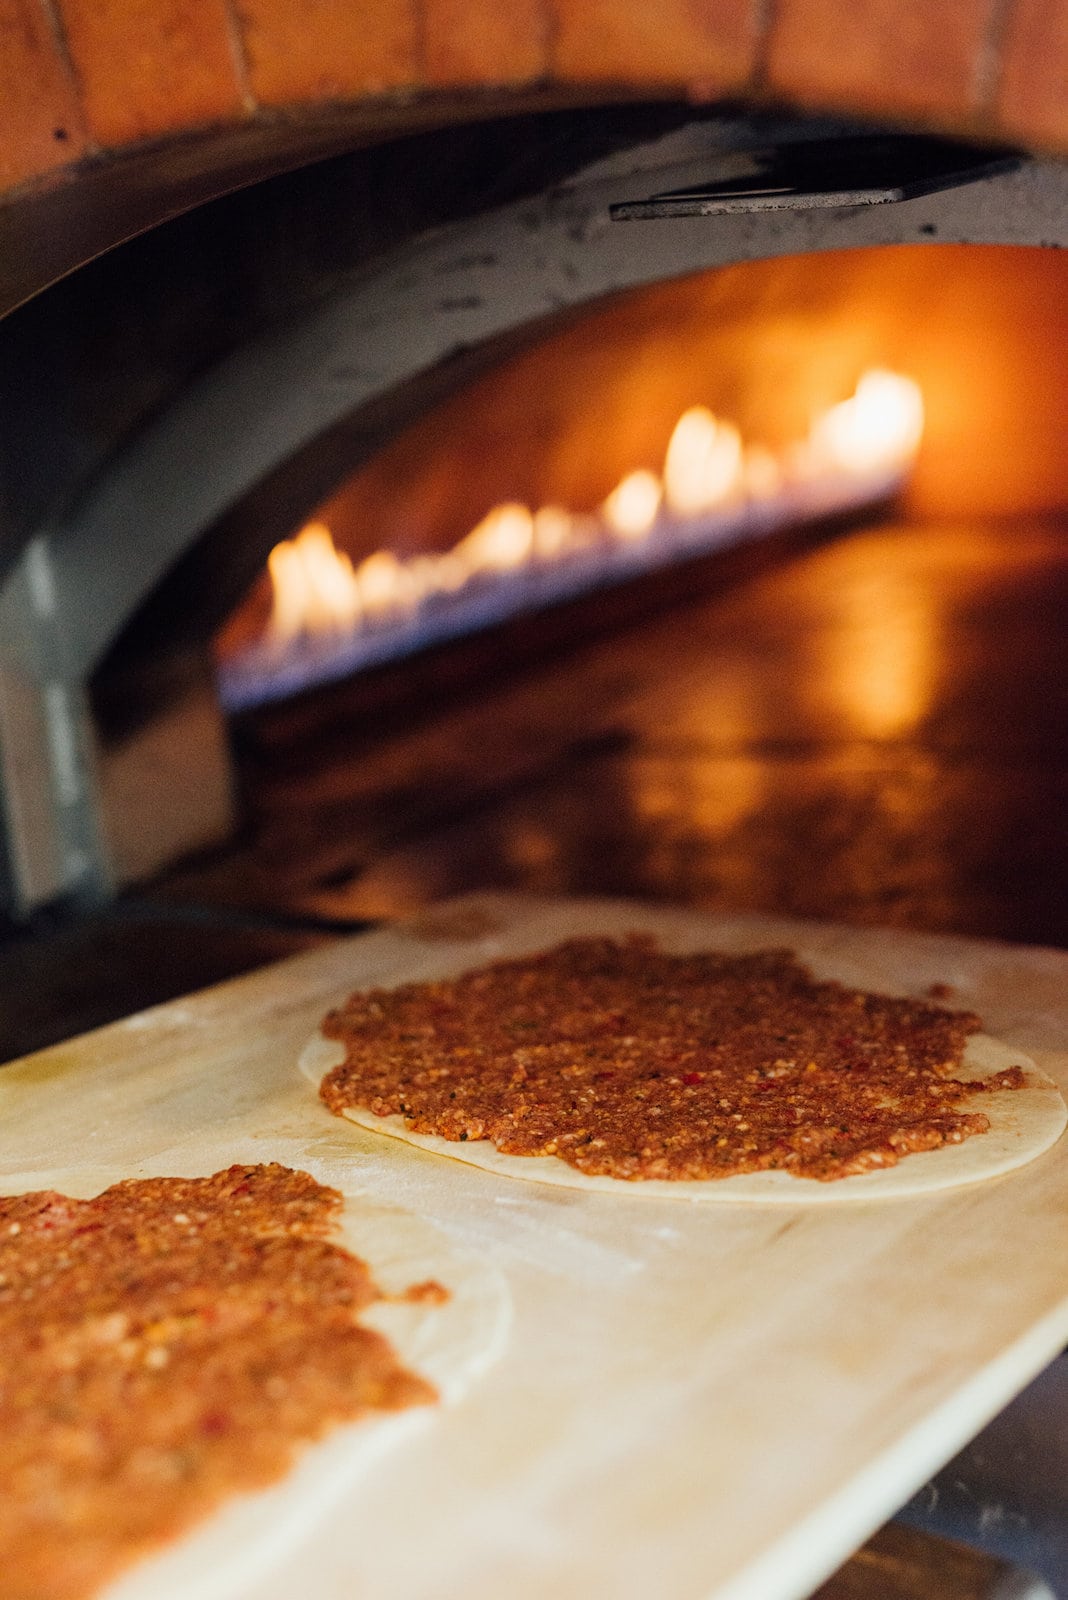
[0,0,1068,1600]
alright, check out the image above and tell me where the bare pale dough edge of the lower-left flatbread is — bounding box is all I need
[13,1173,510,1600]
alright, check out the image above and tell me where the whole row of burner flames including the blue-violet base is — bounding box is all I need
[219,370,923,709]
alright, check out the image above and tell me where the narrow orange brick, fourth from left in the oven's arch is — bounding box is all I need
[424,0,548,88]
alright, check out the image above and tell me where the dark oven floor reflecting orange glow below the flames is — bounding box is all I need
[158,522,1068,946]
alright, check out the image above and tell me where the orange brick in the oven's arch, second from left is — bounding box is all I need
[61,0,243,146]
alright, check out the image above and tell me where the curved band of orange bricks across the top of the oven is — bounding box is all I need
[0,0,1068,192]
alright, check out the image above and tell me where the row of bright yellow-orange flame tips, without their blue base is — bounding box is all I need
[260,370,924,650]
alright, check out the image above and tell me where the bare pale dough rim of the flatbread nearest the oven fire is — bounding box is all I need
[301,1034,1068,1205]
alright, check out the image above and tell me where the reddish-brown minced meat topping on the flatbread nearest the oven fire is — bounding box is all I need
[320,934,1023,1181]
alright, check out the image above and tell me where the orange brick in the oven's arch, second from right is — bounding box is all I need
[767,0,990,120]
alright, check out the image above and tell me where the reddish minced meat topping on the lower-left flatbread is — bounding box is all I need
[0,1165,435,1600]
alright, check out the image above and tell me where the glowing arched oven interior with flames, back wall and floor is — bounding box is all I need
[73,246,1068,942]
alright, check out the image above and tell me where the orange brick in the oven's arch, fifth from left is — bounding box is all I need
[553,0,758,94]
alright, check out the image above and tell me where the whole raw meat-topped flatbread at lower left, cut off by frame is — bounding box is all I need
[0,1163,508,1600]
